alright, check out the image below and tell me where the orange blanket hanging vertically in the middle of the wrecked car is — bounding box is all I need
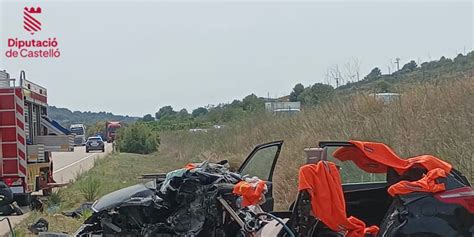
[298,162,379,237]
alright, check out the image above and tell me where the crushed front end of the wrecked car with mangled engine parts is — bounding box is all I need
[75,161,288,236]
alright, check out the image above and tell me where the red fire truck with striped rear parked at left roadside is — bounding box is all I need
[0,71,74,205]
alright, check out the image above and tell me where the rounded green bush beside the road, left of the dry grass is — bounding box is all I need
[117,122,160,154]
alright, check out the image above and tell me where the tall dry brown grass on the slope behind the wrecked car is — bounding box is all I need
[160,77,474,208]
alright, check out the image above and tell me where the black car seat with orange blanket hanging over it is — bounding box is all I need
[289,161,378,237]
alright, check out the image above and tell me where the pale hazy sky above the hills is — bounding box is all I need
[0,0,474,116]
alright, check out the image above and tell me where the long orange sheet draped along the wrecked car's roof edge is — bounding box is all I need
[333,141,452,174]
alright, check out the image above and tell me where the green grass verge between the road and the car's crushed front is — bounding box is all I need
[15,153,191,236]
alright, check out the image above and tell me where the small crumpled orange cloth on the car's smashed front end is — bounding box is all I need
[232,180,266,207]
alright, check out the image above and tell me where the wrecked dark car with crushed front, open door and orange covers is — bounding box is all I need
[75,141,474,237]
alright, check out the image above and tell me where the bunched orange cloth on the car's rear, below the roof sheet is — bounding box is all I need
[388,168,446,196]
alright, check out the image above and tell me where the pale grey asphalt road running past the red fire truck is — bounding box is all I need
[0,143,112,236]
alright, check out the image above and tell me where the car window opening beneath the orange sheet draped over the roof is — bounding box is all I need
[326,147,386,184]
